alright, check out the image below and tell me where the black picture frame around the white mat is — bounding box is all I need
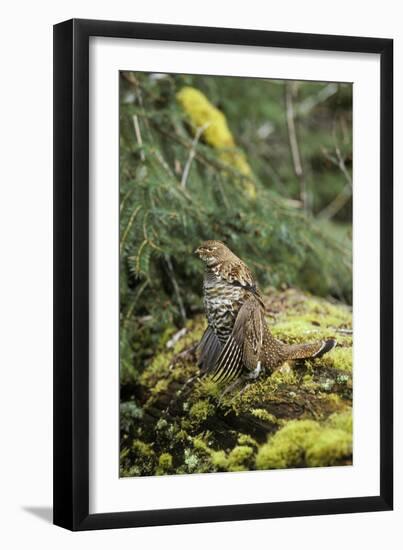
[54,19,393,530]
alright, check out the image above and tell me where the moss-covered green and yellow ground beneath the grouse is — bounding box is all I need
[120,289,352,477]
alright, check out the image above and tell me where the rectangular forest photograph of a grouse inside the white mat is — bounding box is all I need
[119,71,353,478]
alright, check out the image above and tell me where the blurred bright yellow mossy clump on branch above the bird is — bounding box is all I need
[176,86,256,198]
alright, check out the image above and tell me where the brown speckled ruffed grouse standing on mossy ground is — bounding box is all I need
[195,241,336,392]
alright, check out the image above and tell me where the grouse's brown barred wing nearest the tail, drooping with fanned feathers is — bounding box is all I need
[211,296,265,383]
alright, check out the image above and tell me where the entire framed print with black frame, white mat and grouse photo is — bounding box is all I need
[54,20,393,530]
